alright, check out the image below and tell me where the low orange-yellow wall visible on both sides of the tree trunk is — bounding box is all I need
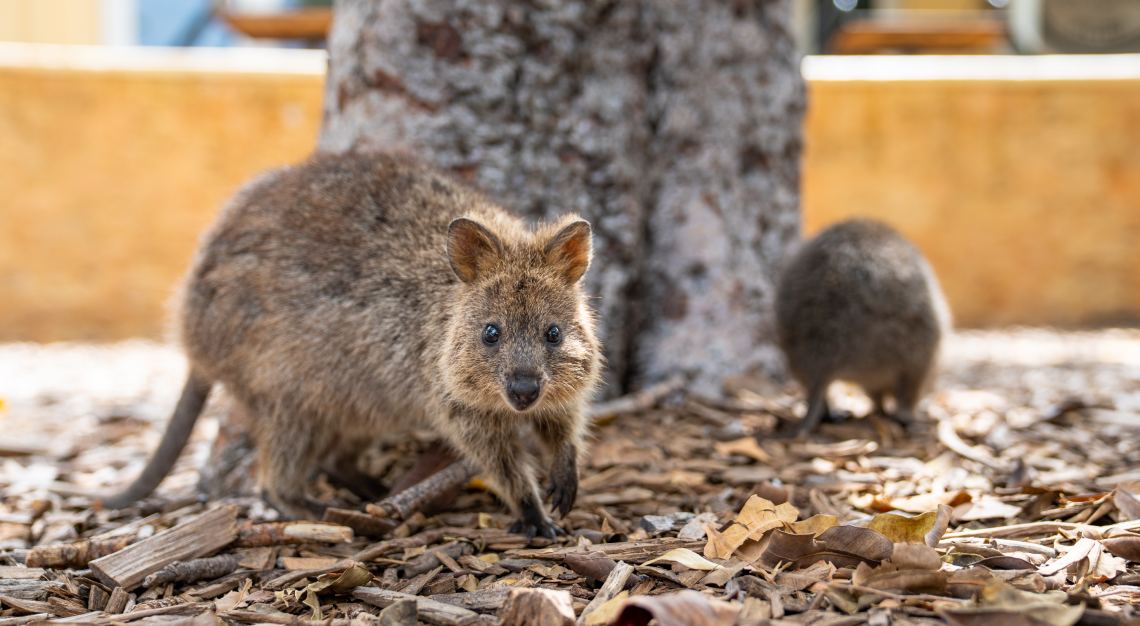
[0,47,1140,341]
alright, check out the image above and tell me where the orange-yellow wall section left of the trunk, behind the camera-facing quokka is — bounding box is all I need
[0,49,323,340]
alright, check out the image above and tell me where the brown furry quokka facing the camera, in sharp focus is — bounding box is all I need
[105,154,601,536]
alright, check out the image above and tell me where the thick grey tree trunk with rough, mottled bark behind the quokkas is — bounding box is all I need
[319,0,804,393]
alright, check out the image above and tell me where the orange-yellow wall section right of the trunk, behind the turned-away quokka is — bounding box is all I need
[804,57,1140,325]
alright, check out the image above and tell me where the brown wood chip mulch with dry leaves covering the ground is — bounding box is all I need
[0,330,1140,626]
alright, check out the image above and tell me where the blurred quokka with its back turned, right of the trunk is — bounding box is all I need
[776,219,950,434]
